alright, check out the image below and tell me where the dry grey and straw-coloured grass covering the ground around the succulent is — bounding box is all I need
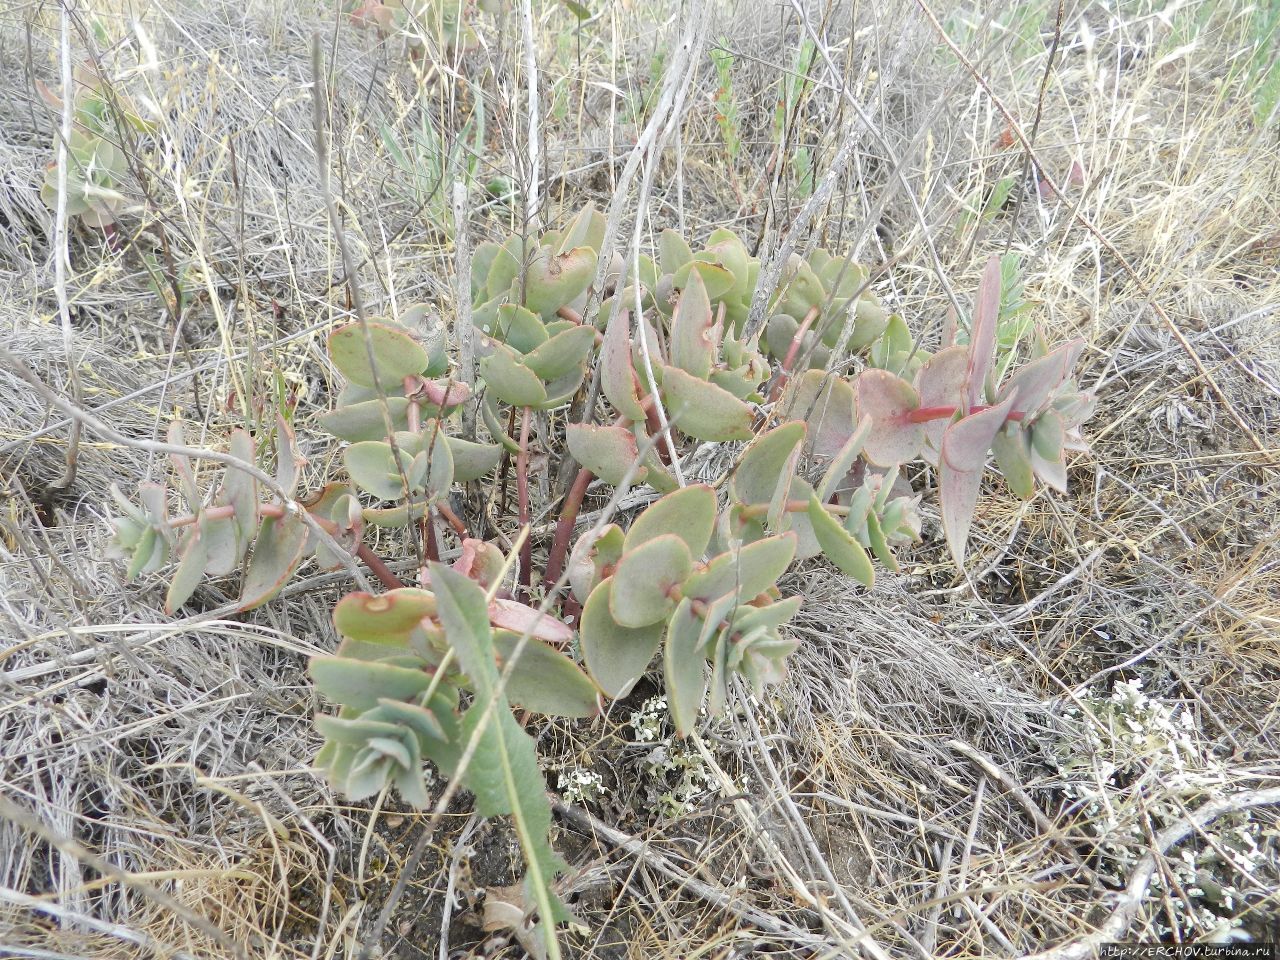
[0,0,1280,957]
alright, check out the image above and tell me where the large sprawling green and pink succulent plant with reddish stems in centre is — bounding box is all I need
[102,207,1093,955]
